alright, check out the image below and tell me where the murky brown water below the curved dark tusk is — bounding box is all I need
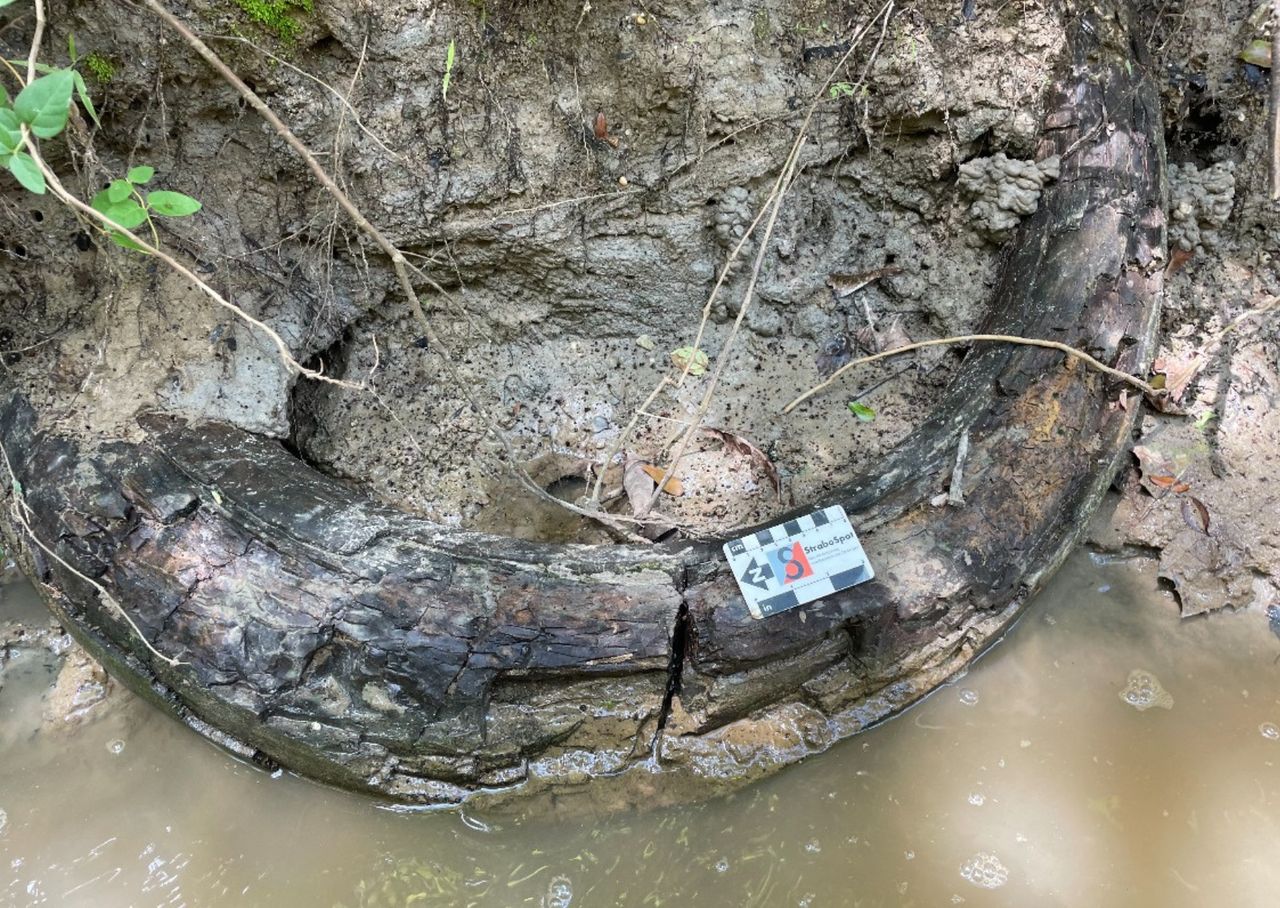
[0,555,1280,908]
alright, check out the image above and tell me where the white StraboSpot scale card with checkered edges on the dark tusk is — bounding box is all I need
[724,505,876,619]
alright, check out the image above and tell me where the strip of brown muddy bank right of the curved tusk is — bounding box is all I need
[1094,0,1280,616]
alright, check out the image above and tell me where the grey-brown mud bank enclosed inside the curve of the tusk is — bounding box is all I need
[0,1,1062,540]
